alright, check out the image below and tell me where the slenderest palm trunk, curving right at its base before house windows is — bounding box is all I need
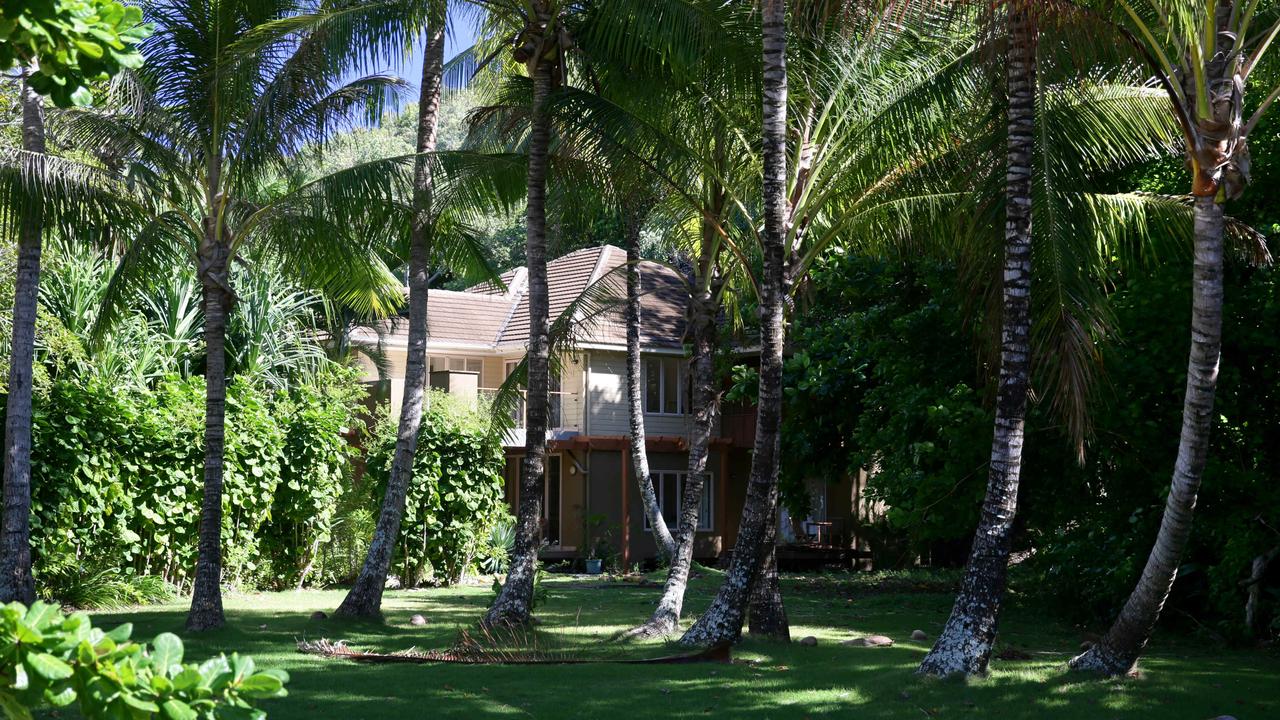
[626,204,676,560]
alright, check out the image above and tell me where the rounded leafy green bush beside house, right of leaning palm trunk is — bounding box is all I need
[365,391,508,585]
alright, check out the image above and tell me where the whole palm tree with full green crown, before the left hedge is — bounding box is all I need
[68,0,408,630]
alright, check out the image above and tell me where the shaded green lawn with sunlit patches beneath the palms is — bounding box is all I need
[82,575,1280,720]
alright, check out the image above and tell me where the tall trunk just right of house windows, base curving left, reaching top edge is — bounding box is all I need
[680,0,787,644]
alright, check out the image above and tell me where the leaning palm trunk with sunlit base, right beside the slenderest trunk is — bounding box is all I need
[627,288,719,638]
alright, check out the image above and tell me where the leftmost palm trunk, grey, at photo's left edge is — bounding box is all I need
[0,76,45,605]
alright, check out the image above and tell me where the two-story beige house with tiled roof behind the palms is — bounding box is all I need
[357,245,870,566]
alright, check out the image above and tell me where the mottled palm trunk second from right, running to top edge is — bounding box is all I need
[918,1,1037,676]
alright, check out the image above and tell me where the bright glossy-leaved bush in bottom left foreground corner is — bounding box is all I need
[0,602,288,720]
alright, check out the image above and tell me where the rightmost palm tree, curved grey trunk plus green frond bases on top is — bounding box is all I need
[1070,0,1280,675]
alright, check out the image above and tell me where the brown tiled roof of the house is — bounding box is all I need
[369,245,686,348]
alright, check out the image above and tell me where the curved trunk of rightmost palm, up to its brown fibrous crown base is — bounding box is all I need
[1070,0,1254,675]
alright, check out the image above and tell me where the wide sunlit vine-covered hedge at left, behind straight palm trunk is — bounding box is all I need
[5,368,362,589]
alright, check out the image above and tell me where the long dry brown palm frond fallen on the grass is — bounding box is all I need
[298,628,732,665]
